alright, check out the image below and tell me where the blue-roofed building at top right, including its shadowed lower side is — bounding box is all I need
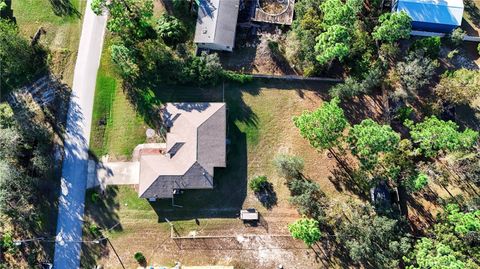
[392,0,464,33]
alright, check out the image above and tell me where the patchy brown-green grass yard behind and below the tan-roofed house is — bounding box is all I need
[83,81,380,268]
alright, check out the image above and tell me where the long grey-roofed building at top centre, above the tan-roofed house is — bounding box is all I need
[194,0,240,51]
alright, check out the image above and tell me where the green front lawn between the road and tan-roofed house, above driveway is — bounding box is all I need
[90,36,147,159]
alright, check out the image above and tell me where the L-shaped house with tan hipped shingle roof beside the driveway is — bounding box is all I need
[138,103,227,199]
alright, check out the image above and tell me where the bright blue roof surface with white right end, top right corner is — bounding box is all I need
[395,0,463,26]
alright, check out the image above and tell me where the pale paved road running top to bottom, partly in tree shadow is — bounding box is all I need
[54,0,107,269]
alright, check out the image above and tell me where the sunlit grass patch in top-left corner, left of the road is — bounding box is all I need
[12,0,86,86]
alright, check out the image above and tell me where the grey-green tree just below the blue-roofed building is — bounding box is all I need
[396,51,438,94]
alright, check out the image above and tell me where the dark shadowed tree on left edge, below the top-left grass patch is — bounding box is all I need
[0,18,47,94]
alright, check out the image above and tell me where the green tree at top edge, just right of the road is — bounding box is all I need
[91,0,153,41]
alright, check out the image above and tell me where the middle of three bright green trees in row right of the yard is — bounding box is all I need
[347,119,400,169]
